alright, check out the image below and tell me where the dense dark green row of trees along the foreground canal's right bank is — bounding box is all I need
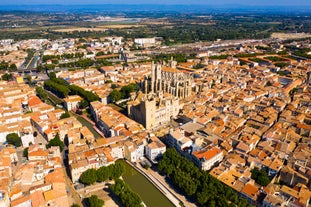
[158,148,251,206]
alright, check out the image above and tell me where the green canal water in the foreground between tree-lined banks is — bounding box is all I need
[118,160,174,207]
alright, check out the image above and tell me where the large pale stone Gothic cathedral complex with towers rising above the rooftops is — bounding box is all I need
[127,62,192,129]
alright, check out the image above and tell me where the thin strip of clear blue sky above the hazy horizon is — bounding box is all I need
[0,0,311,6]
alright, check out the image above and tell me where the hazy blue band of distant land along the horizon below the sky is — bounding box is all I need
[0,3,311,12]
